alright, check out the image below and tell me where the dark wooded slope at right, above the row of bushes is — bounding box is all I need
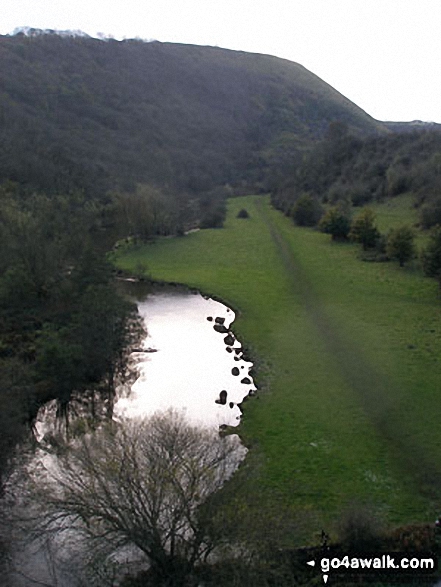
[272,123,441,227]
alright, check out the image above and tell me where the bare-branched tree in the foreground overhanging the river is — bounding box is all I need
[26,412,243,586]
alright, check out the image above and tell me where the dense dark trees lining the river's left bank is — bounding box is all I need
[0,184,139,492]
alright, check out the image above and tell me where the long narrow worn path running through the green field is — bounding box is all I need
[253,201,441,504]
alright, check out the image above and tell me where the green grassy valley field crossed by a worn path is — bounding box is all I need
[116,196,441,541]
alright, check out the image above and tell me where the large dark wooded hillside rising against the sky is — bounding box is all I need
[0,33,383,194]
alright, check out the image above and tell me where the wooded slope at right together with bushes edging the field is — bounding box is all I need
[272,122,441,283]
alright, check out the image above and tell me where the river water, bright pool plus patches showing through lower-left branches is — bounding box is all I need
[6,284,256,587]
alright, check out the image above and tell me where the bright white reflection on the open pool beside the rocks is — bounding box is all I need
[115,290,256,426]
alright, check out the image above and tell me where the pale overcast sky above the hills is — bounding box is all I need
[0,0,441,123]
